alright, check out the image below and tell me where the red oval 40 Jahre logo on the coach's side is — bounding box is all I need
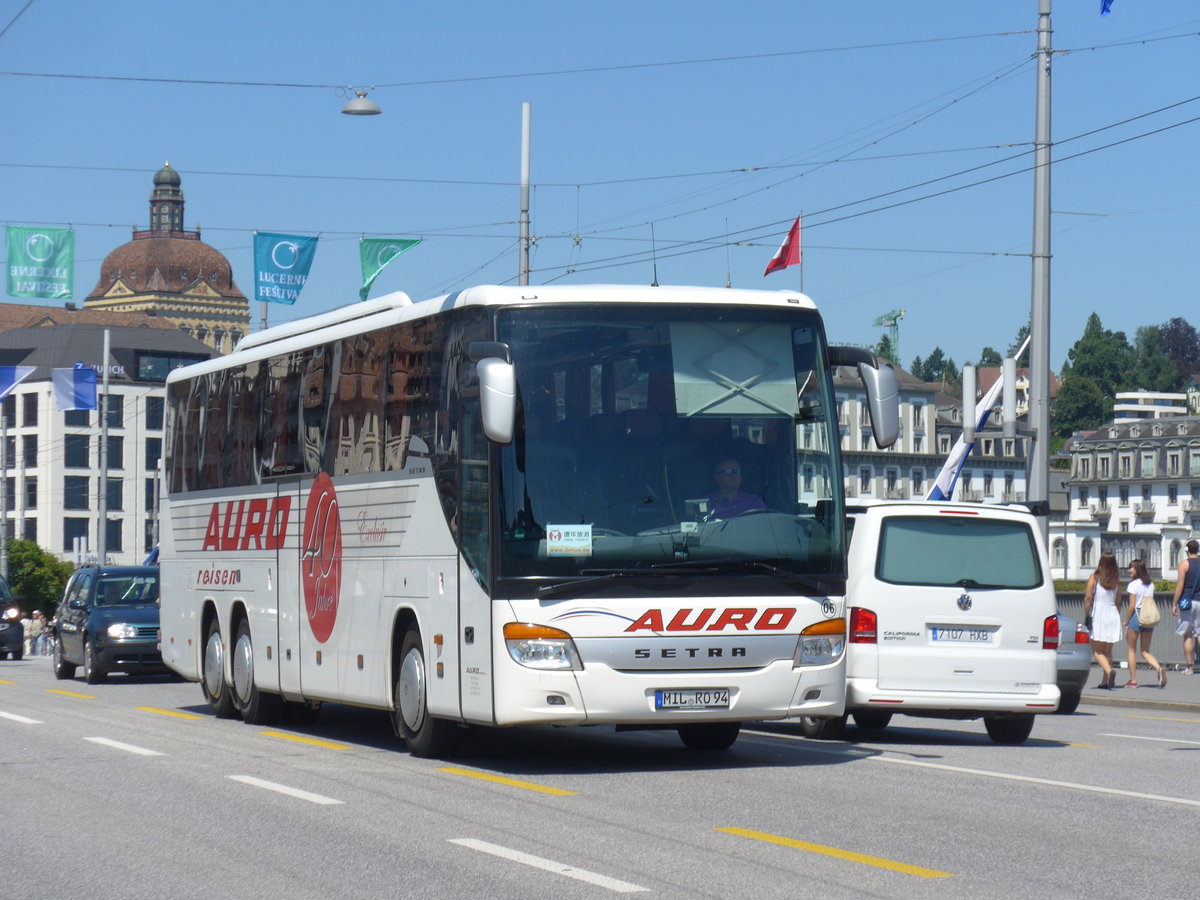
[300,472,342,643]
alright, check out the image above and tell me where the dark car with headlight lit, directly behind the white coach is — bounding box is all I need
[54,565,169,684]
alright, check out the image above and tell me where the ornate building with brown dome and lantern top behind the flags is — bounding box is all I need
[84,162,250,353]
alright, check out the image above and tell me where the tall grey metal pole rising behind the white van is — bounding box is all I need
[1026,0,1052,541]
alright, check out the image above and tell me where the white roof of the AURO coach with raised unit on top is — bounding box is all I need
[167,284,816,384]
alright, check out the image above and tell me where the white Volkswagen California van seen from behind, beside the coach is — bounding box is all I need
[804,500,1060,744]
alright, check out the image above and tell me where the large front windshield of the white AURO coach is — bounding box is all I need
[497,305,845,578]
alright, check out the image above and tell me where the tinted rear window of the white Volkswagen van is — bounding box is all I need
[875,516,1042,588]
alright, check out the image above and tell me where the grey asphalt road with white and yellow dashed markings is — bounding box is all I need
[0,659,1200,900]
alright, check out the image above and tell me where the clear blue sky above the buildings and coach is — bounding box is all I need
[0,0,1200,370]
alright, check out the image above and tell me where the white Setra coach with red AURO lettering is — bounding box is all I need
[160,286,899,756]
